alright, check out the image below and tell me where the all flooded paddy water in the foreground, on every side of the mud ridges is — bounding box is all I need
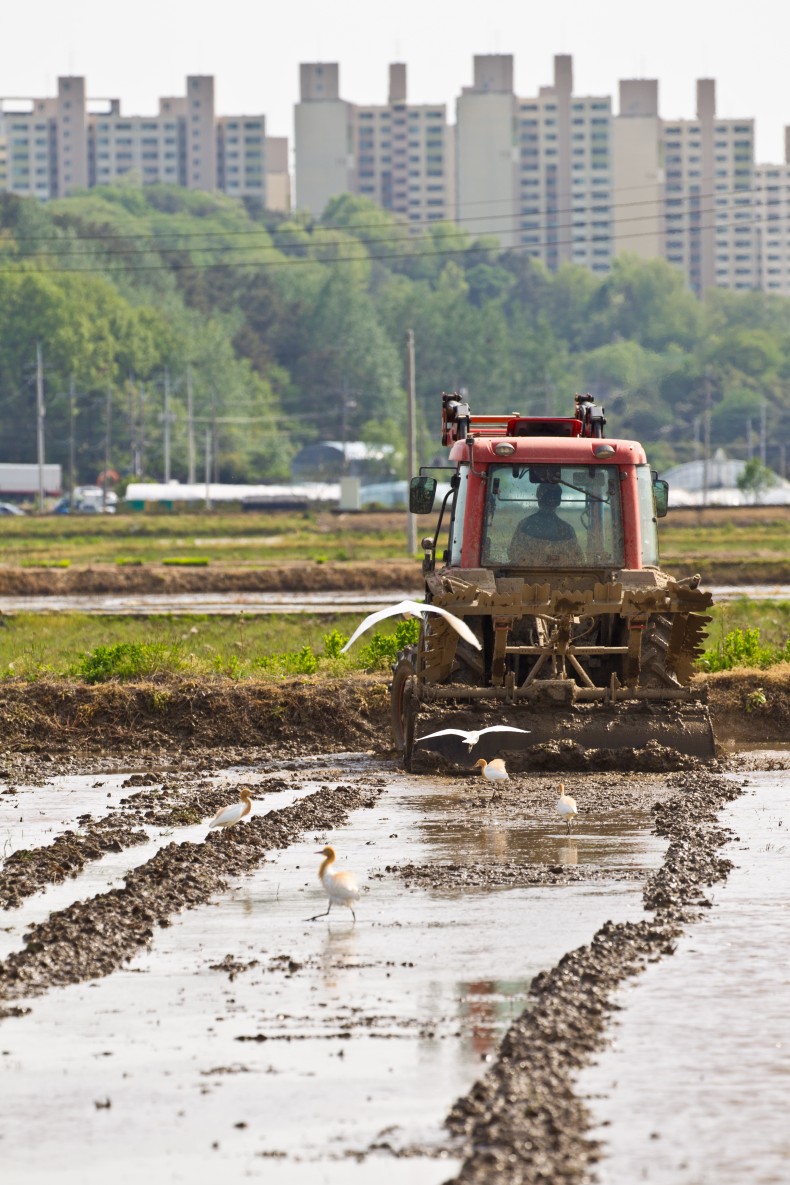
[0,754,790,1185]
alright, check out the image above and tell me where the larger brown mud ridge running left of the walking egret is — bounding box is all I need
[0,779,386,1014]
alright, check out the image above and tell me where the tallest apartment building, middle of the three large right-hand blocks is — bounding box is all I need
[456,55,614,273]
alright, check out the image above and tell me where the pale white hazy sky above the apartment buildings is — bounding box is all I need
[0,0,790,161]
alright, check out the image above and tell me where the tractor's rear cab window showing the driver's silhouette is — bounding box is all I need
[482,465,623,568]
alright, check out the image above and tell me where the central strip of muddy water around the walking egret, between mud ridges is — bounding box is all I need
[0,775,663,1185]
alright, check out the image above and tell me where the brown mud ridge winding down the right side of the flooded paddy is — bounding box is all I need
[447,773,743,1185]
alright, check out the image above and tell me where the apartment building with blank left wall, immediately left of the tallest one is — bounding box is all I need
[294,62,455,226]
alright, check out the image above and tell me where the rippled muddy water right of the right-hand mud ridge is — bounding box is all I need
[580,771,790,1185]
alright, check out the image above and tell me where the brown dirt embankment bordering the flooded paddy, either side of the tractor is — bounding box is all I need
[0,664,790,758]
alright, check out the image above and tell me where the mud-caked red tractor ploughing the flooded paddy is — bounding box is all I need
[391,395,714,769]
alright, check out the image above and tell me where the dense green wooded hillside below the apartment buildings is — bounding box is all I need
[0,185,790,481]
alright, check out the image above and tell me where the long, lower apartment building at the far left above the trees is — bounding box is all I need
[0,75,290,210]
